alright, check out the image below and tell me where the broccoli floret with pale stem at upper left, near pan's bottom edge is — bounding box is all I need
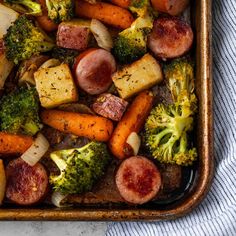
[50,142,110,194]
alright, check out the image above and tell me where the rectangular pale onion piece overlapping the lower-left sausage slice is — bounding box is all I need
[21,133,50,166]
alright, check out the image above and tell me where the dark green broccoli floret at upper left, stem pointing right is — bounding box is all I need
[4,16,54,64]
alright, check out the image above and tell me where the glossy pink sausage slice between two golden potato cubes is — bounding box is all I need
[74,49,116,95]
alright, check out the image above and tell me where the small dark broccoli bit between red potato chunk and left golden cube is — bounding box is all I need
[52,47,79,67]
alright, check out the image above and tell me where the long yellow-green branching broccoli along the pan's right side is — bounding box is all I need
[145,58,197,166]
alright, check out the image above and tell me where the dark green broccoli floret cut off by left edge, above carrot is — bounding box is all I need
[0,87,41,135]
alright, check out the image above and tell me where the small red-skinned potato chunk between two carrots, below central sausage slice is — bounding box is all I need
[93,93,128,121]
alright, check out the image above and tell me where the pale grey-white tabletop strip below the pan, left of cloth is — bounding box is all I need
[0,221,107,236]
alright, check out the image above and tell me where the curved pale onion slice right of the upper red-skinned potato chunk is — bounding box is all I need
[90,19,113,51]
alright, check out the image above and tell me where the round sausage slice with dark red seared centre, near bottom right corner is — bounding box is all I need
[115,156,161,204]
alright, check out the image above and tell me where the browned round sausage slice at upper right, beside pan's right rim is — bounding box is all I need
[148,17,193,59]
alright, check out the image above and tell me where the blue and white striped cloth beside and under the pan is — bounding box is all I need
[106,0,236,236]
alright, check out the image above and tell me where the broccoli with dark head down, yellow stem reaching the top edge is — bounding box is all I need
[113,0,153,64]
